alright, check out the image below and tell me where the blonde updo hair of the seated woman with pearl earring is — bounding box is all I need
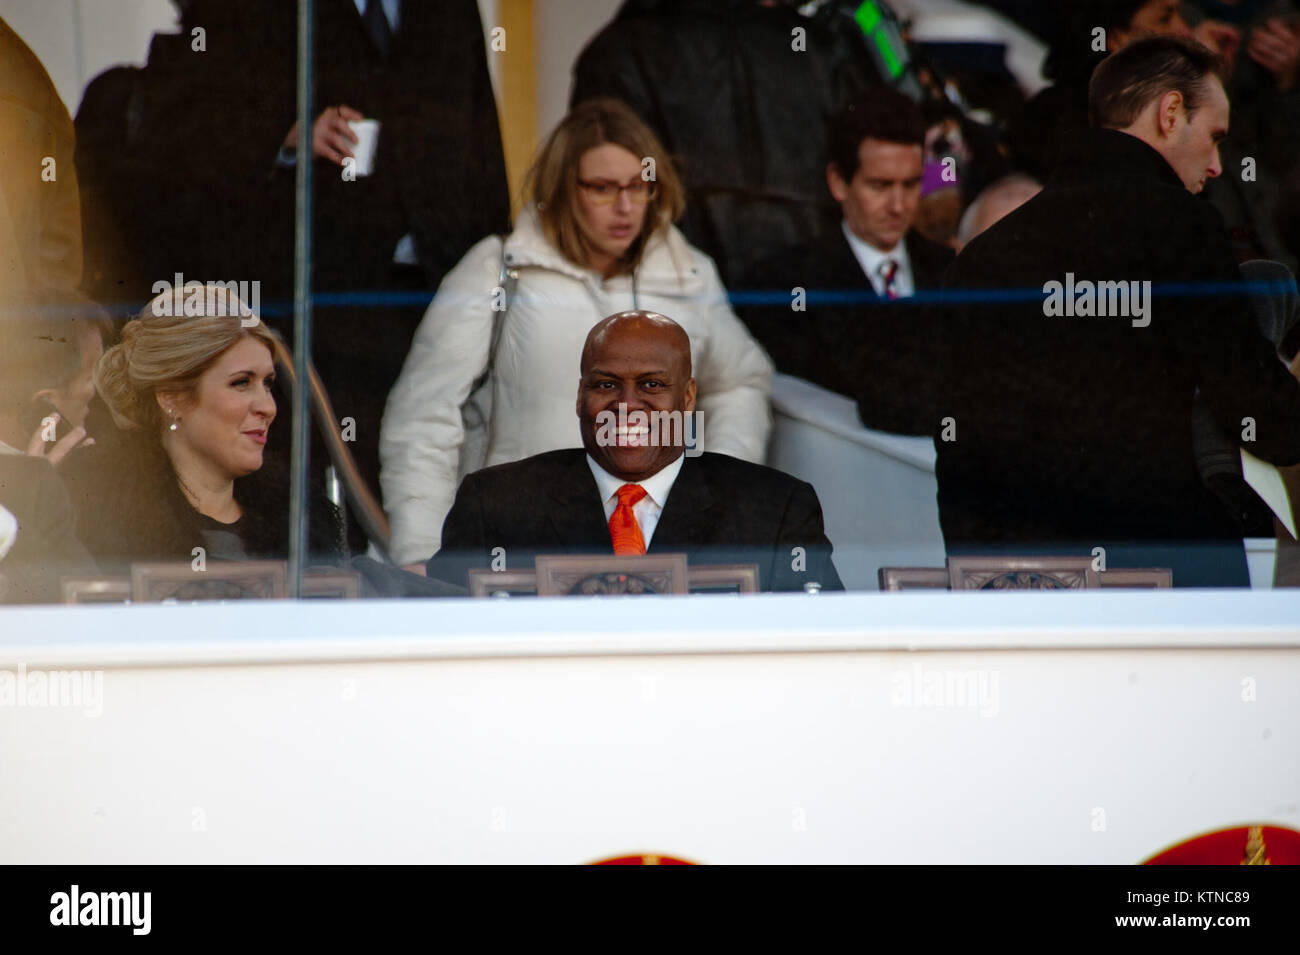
[95,283,278,431]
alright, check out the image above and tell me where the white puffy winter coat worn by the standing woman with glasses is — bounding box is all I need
[380,209,772,564]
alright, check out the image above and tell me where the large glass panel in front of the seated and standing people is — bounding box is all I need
[0,0,1300,613]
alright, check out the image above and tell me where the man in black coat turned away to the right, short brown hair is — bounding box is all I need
[935,38,1300,586]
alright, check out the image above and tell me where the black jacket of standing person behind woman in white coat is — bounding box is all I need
[571,0,879,287]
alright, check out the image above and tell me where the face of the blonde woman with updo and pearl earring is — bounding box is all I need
[159,337,276,479]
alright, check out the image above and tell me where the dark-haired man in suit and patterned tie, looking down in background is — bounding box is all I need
[741,87,953,434]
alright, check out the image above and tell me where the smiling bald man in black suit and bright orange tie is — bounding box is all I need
[428,312,844,590]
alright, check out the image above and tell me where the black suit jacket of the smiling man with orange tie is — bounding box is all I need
[428,448,844,590]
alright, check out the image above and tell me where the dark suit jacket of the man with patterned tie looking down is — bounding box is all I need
[738,227,953,434]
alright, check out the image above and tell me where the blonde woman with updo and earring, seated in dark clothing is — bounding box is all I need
[70,287,337,569]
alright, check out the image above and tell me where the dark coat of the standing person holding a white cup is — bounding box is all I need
[77,0,510,304]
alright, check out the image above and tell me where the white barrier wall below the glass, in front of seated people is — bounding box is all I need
[0,591,1300,864]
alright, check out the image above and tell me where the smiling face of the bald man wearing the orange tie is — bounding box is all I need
[577,312,696,482]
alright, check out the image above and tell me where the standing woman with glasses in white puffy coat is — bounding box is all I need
[380,99,772,564]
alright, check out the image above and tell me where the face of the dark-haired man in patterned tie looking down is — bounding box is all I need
[826,136,924,252]
